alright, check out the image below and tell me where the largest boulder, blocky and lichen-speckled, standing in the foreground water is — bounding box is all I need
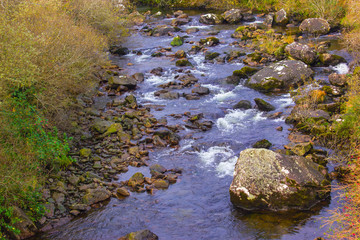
[230,149,329,211]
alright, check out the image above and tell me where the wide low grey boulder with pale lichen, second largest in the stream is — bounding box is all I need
[247,60,314,92]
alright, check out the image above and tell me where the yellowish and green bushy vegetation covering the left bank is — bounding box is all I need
[0,0,126,239]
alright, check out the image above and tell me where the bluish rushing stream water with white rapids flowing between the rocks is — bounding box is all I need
[42,8,348,240]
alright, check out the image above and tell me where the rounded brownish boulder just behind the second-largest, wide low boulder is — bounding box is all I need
[285,42,317,65]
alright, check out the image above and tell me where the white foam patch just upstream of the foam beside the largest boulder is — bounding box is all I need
[216,109,267,132]
